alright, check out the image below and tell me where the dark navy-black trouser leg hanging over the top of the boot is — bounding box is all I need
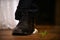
[15,0,38,20]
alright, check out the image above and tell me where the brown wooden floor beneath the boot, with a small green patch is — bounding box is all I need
[0,25,60,40]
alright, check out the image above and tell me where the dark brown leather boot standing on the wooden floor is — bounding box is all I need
[13,12,34,35]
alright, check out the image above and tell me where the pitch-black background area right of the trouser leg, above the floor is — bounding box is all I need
[35,0,55,25]
